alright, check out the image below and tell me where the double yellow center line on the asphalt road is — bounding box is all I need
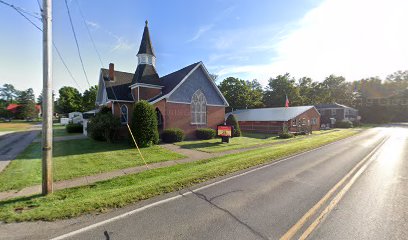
[280,138,388,240]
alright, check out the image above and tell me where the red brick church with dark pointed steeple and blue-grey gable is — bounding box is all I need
[96,21,228,137]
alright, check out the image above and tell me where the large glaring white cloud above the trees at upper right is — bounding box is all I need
[217,0,408,83]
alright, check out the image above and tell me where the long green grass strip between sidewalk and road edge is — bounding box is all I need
[0,130,358,222]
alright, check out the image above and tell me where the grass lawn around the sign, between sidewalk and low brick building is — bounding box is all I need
[176,129,338,153]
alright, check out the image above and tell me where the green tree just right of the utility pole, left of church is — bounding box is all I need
[58,86,83,114]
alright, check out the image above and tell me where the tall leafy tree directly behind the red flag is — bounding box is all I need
[263,73,302,107]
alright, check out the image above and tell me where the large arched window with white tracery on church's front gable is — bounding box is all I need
[191,90,207,125]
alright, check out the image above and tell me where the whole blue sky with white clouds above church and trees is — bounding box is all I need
[0,0,408,95]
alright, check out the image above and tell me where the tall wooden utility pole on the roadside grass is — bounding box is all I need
[42,0,53,195]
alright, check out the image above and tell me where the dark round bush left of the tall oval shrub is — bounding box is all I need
[87,107,120,143]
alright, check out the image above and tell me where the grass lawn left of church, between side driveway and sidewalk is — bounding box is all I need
[0,139,185,191]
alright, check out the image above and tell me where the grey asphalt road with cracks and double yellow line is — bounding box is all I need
[0,126,408,240]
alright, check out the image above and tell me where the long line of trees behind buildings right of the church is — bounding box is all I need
[218,71,408,122]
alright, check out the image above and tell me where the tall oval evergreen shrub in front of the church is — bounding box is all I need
[131,100,159,147]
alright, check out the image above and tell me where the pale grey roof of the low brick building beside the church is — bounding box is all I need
[230,106,314,122]
